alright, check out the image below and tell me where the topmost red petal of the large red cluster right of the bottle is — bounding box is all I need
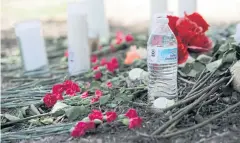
[185,12,209,32]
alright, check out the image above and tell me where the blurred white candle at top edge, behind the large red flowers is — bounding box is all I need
[178,0,197,17]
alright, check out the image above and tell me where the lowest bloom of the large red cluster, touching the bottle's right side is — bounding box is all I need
[176,37,189,64]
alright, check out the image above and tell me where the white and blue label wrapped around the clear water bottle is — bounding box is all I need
[148,46,178,64]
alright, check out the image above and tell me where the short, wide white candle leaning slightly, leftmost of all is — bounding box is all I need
[15,20,48,72]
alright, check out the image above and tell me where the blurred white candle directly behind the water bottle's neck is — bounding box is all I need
[149,0,168,33]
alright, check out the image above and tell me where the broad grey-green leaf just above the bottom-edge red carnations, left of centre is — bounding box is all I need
[65,106,89,121]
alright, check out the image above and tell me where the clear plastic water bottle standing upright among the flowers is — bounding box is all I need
[147,14,178,101]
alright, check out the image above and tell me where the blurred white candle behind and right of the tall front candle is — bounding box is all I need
[87,0,110,39]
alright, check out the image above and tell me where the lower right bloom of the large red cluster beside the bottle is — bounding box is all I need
[188,34,212,52]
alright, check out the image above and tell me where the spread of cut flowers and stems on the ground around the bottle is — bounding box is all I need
[1,10,240,141]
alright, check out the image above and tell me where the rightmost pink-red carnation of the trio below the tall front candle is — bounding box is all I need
[63,80,81,96]
